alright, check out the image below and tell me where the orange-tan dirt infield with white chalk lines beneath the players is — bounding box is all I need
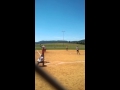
[35,50,85,90]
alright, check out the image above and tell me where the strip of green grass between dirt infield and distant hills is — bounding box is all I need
[35,43,85,50]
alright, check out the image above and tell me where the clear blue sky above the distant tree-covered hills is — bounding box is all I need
[35,0,85,42]
